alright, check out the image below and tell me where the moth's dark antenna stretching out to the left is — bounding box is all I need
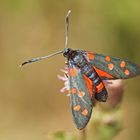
[20,51,63,67]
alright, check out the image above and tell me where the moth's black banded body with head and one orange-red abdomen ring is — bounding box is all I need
[63,48,107,102]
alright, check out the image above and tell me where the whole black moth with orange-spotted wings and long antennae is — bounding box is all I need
[21,10,140,129]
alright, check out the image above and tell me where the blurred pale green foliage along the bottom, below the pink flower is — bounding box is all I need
[48,106,123,140]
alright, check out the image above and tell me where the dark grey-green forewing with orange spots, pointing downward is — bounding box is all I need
[68,61,93,129]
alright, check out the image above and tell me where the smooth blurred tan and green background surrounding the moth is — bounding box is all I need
[0,0,140,140]
